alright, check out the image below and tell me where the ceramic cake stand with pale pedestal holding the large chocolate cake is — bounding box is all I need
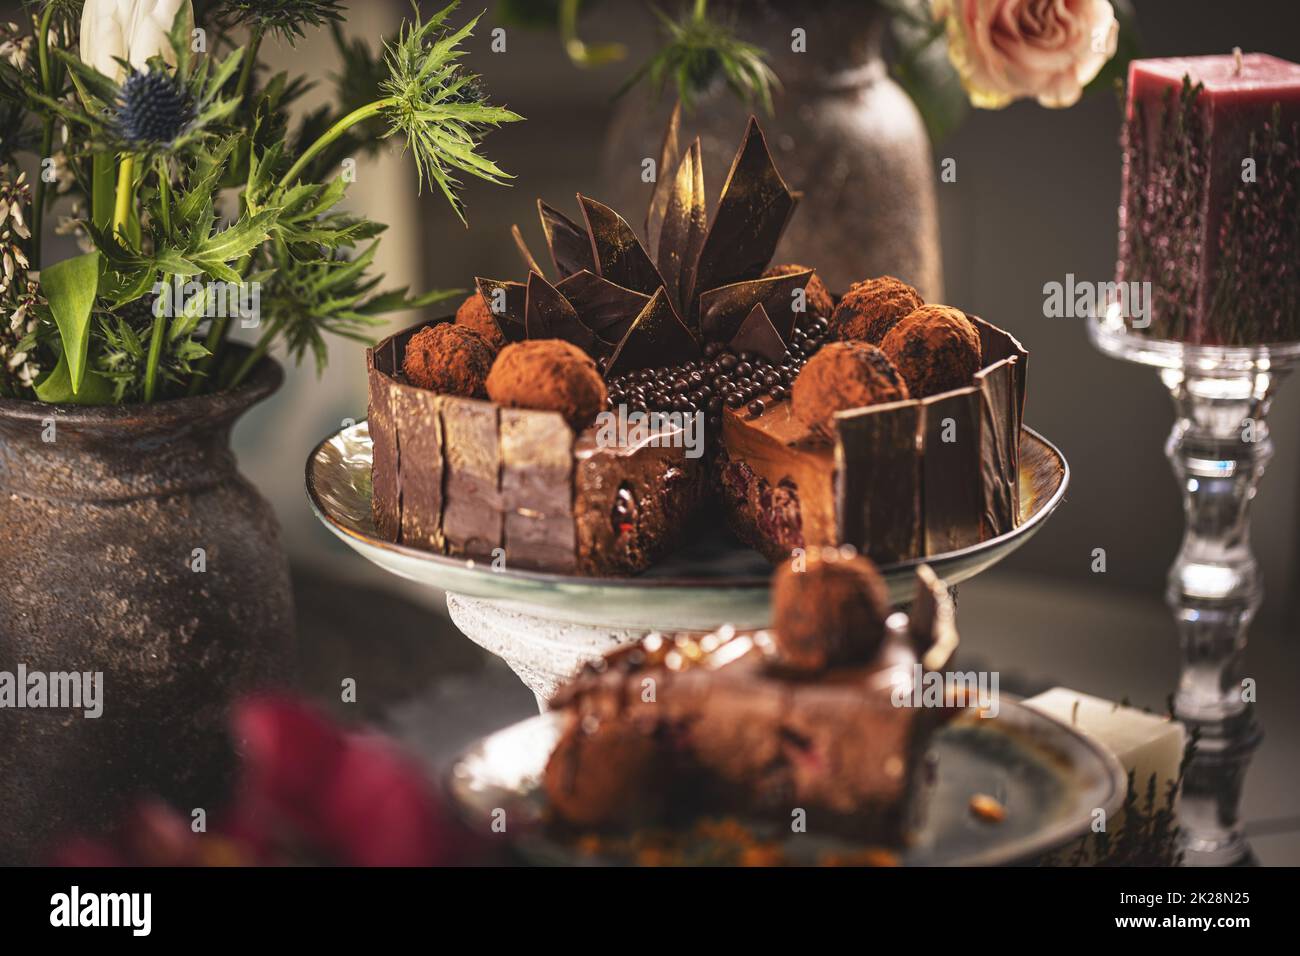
[307,421,1070,708]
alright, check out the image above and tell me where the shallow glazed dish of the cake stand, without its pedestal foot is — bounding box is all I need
[307,421,1070,630]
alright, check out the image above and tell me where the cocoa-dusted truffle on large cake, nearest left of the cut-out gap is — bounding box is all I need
[488,338,607,429]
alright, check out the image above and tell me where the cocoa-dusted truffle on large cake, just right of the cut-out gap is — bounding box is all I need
[790,342,910,436]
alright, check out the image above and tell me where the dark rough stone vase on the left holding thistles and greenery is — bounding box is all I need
[0,360,294,862]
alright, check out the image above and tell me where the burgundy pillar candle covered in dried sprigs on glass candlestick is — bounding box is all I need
[1117,51,1300,346]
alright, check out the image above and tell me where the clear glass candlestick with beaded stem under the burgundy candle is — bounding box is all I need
[1088,310,1300,866]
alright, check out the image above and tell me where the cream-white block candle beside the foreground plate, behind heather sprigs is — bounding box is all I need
[1024,687,1186,805]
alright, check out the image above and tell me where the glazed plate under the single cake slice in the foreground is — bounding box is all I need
[447,695,1127,866]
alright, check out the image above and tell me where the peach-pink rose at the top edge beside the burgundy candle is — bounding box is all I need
[931,0,1119,109]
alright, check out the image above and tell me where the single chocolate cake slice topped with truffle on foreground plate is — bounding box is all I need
[542,549,957,845]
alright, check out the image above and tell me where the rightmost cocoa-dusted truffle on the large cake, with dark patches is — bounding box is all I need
[880,306,980,398]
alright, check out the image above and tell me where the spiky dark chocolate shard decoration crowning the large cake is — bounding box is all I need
[467,108,813,375]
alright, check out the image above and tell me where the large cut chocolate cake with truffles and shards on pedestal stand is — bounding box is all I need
[367,113,1027,575]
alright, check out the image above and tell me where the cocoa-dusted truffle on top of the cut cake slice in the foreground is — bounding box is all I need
[772,548,891,671]
